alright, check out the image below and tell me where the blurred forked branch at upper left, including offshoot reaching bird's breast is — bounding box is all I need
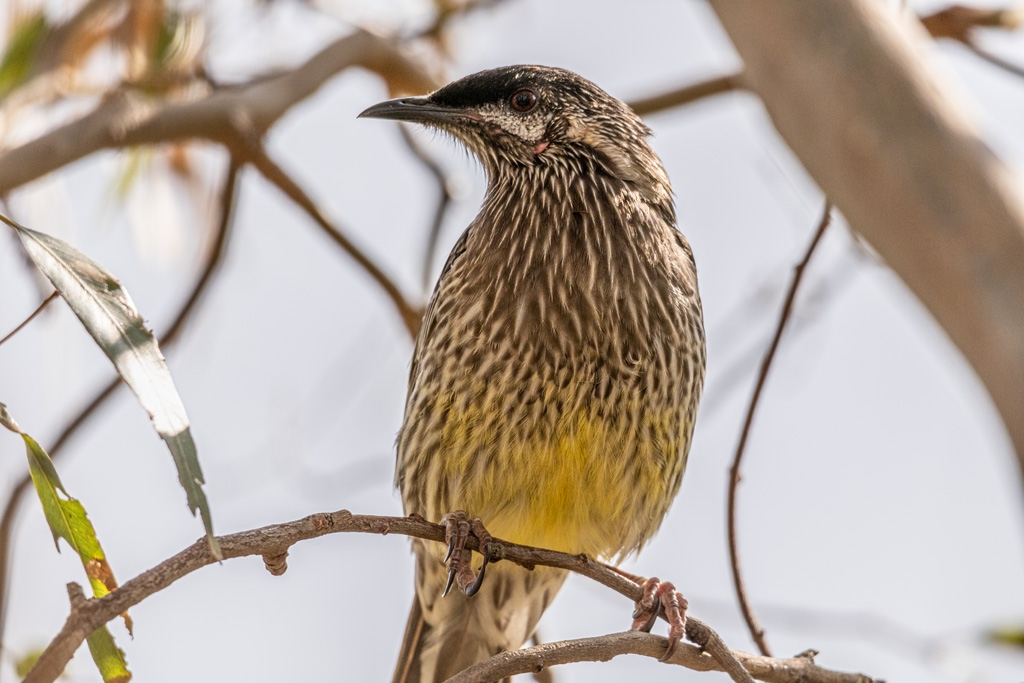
[0,31,434,338]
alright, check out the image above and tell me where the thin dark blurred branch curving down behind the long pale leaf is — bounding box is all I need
[0,158,240,659]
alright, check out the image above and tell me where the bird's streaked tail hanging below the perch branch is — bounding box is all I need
[391,553,565,683]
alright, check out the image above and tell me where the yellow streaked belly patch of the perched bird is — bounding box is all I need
[437,405,680,558]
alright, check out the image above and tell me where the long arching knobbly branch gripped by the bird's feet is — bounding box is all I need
[24,510,870,683]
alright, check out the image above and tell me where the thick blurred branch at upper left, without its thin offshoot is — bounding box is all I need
[0,31,436,195]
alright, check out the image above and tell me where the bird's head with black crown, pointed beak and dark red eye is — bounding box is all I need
[359,66,671,202]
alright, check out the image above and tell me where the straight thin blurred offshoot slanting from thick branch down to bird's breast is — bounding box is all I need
[240,141,423,339]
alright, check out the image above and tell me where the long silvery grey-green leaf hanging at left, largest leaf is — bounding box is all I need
[0,214,220,559]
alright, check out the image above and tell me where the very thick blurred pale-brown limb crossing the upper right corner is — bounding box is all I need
[711,0,1024,491]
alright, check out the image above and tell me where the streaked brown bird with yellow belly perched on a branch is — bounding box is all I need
[359,66,706,683]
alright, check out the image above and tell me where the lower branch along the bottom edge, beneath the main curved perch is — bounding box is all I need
[446,631,871,683]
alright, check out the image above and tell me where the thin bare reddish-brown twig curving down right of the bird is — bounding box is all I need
[727,200,831,656]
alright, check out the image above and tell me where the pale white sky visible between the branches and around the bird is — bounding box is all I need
[0,0,1024,683]
